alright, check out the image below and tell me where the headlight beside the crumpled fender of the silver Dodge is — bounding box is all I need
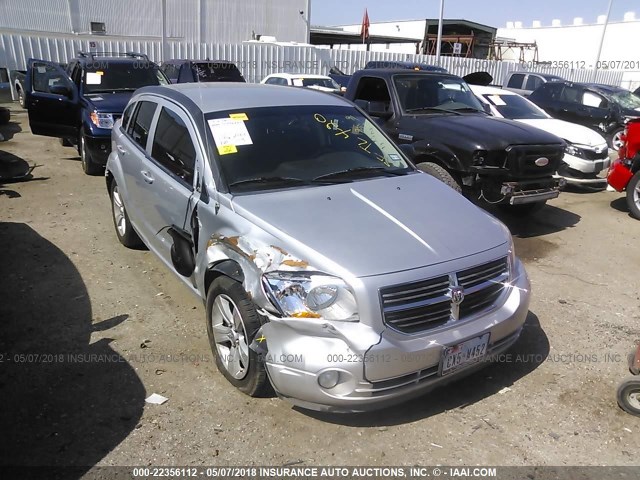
[262,272,358,322]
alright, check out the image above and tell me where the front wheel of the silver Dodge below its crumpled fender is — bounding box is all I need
[207,275,271,397]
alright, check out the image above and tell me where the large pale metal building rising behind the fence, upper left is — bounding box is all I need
[0,0,307,43]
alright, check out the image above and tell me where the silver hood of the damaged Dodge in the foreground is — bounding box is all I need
[232,173,508,277]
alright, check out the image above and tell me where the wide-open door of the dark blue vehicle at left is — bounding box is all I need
[25,59,80,138]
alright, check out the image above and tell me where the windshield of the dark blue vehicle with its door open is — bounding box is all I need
[84,62,169,93]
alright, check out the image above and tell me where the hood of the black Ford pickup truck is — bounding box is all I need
[407,114,561,150]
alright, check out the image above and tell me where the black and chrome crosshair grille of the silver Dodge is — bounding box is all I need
[380,257,509,333]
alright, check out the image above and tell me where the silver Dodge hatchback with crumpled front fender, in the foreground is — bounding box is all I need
[106,83,530,412]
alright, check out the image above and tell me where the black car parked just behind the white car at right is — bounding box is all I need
[529,81,640,150]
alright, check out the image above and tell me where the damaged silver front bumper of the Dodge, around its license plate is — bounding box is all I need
[251,262,530,412]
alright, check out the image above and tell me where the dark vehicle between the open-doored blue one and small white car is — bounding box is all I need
[161,60,245,83]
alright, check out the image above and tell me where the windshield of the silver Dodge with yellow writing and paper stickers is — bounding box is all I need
[205,105,413,193]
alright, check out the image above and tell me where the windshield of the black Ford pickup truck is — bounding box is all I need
[393,75,484,113]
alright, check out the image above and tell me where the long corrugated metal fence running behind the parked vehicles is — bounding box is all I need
[0,34,624,85]
